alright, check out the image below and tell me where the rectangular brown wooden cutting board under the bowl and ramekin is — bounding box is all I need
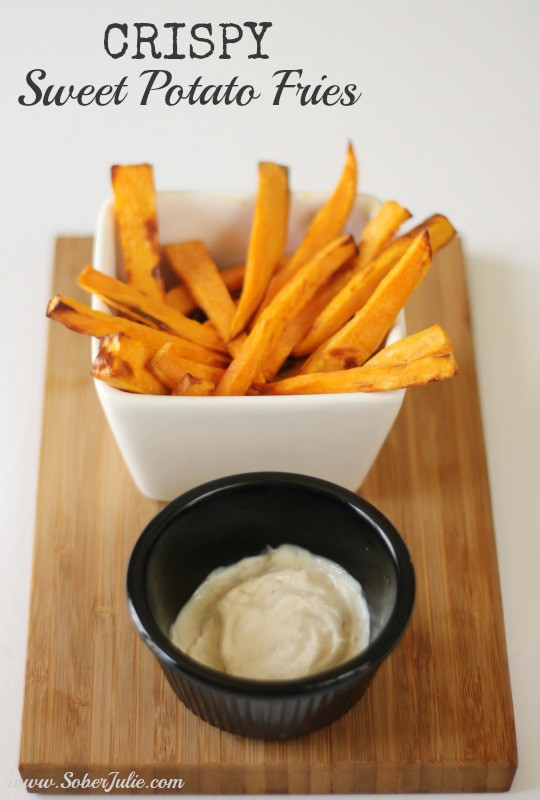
[20,238,517,794]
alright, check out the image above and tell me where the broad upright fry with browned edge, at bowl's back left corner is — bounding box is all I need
[111,164,164,299]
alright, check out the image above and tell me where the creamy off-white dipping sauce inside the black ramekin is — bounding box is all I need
[170,545,369,680]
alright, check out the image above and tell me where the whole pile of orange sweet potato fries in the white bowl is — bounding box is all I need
[47,145,457,395]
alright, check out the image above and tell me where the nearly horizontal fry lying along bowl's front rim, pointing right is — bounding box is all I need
[254,353,458,394]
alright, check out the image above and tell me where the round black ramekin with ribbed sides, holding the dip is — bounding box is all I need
[127,472,415,739]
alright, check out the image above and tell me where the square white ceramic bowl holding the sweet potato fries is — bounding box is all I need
[92,192,405,501]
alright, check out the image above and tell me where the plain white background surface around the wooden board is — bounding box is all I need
[0,0,540,798]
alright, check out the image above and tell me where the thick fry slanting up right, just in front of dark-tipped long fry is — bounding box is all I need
[299,230,431,374]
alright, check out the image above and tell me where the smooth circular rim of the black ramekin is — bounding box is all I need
[126,472,416,697]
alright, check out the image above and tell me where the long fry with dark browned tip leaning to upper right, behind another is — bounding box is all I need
[293,214,455,357]
